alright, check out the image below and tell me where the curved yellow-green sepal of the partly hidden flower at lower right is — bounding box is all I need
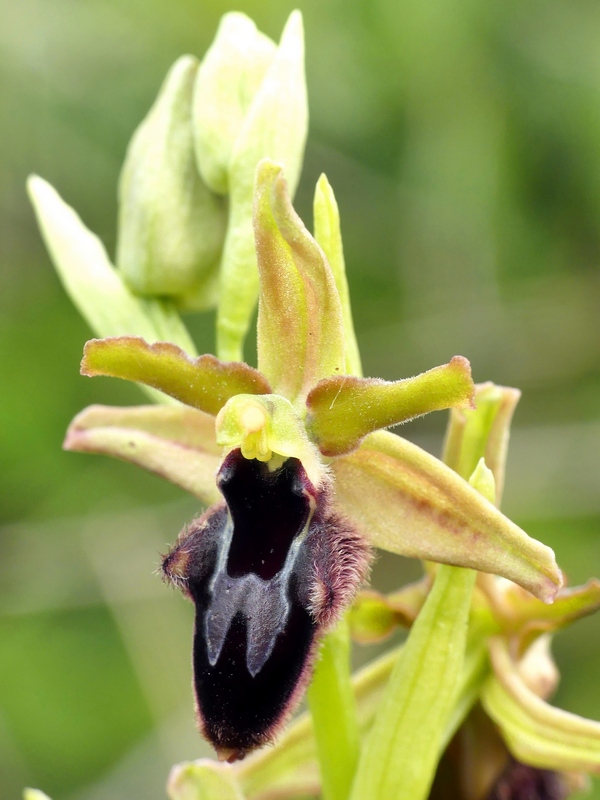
[481,637,600,773]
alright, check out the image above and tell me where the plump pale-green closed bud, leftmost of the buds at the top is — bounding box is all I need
[117,56,226,309]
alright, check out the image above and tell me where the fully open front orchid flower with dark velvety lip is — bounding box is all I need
[43,160,561,760]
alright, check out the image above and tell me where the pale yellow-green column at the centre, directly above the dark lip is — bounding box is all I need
[216,390,326,488]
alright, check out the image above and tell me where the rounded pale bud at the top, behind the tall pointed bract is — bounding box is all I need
[193,11,277,194]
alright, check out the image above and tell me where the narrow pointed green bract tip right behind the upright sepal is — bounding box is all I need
[313,174,362,376]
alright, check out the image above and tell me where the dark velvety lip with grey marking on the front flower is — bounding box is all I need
[162,450,368,761]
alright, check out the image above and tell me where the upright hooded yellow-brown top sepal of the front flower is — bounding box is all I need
[255,161,345,405]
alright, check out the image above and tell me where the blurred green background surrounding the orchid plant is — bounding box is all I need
[0,0,600,800]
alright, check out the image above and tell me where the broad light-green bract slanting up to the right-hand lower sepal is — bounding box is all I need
[350,566,476,800]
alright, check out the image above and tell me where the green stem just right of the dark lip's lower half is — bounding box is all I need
[308,619,360,800]
